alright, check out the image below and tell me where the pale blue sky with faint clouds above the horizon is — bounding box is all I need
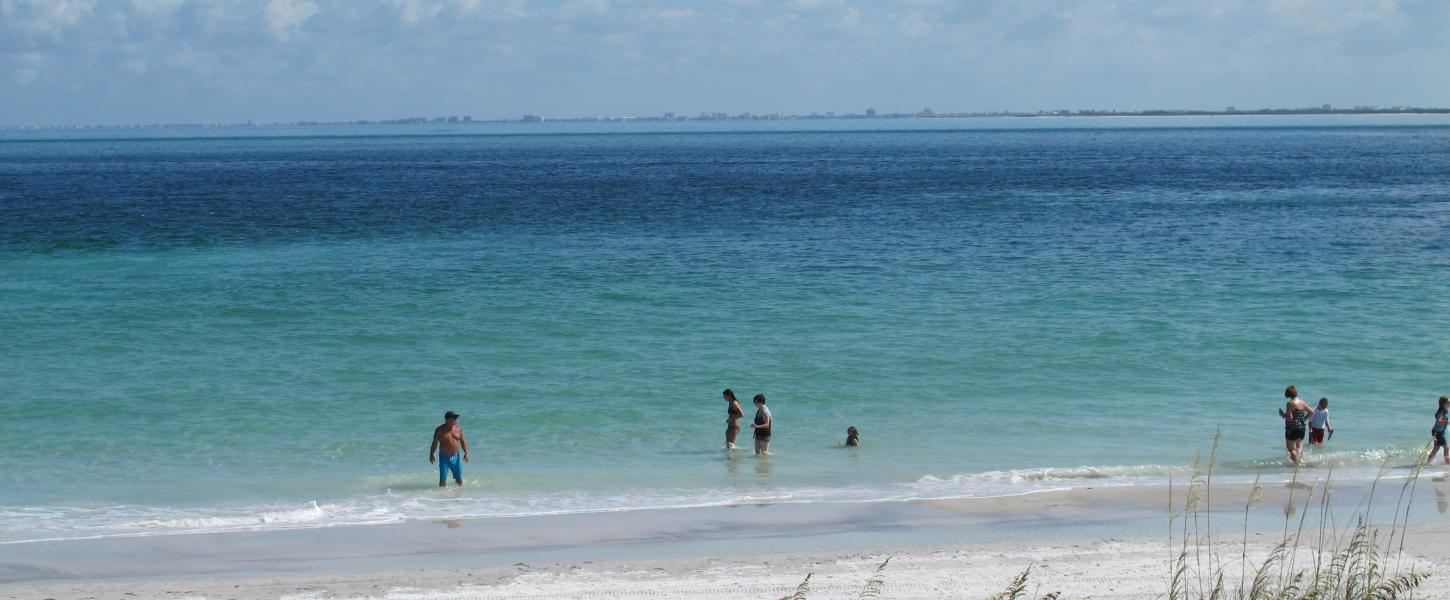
[0,0,1450,126]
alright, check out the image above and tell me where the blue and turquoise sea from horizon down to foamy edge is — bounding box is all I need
[0,117,1450,542]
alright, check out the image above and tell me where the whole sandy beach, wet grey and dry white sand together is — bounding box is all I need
[0,475,1450,600]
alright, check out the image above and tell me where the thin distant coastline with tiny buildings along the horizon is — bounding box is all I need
[0,106,1450,130]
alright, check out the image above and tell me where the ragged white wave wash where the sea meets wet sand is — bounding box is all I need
[0,455,1450,548]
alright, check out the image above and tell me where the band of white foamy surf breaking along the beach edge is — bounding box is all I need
[0,448,1412,543]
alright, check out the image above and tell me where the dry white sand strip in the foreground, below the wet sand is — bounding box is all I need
[11,530,1450,600]
